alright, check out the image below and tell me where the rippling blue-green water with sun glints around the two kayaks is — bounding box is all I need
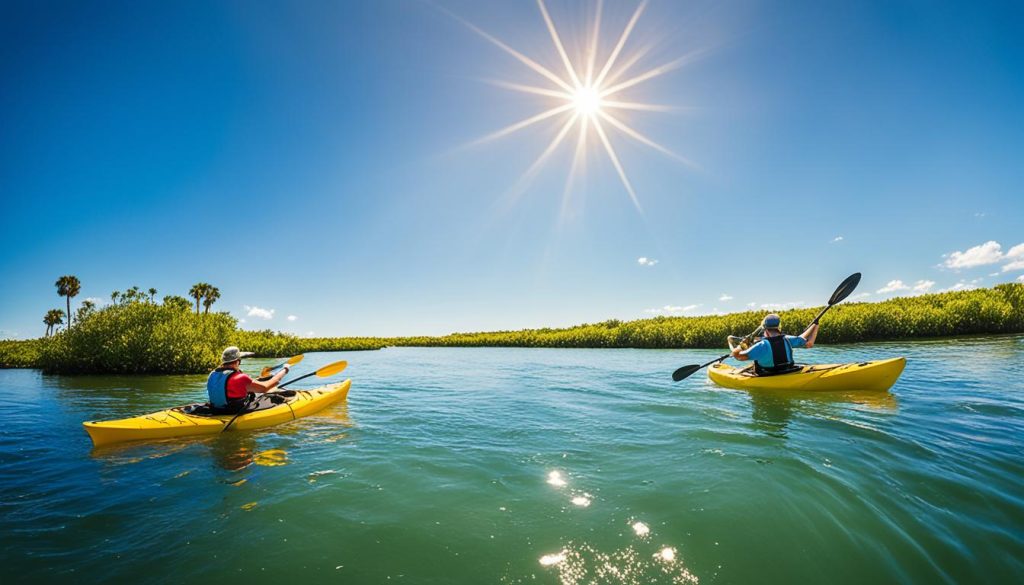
[0,336,1024,584]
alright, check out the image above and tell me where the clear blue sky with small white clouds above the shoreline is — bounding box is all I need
[0,0,1024,338]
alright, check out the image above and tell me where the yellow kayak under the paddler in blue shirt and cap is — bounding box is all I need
[708,358,906,392]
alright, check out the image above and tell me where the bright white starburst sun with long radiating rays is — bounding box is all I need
[450,0,697,213]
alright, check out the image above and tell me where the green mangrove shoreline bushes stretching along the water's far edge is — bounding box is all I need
[0,284,1024,373]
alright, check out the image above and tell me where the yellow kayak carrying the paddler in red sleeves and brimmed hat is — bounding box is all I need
[82,380,352,447]
